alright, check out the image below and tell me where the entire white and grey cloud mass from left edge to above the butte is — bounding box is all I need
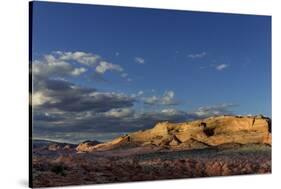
[31,51,234,141]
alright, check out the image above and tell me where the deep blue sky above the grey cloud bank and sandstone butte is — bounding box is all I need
[32,2,271,143]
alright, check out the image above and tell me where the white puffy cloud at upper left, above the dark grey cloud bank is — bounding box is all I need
[32,51,123,78]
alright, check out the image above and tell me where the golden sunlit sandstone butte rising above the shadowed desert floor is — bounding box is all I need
[76,116,271,152]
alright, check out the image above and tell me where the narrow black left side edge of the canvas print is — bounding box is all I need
[28,2,33,188]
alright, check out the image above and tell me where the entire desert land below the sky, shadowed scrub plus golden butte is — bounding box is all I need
[32,116,271,187]
